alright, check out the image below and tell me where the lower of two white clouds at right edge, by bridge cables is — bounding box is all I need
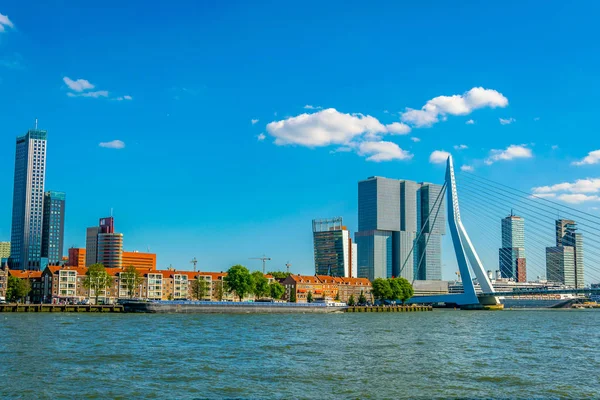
[532,178,600,204]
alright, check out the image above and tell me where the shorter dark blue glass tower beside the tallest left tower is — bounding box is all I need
[42,191,65,265]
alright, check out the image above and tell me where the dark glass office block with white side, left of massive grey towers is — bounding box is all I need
[312,217,355,277]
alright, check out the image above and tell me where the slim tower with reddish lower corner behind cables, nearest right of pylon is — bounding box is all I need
[498,212,527,282]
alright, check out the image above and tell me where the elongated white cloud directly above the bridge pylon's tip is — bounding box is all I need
[402,87,508,127]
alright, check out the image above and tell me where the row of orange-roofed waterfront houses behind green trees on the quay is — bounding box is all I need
[0,266,371,304]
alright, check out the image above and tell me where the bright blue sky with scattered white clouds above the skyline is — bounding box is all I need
[0,0,600,276]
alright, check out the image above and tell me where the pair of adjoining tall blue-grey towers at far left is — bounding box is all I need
[9,122,65,270]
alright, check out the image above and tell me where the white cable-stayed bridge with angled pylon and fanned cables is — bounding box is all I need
[409,157,600,307]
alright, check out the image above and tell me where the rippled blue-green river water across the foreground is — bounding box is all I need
[0,310,600,399]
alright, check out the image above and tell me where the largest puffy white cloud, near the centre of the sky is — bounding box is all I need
[267,108,388,147]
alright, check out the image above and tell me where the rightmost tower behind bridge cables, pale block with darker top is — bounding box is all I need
[546,219,584,289]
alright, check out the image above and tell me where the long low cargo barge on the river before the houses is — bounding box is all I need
[120,300,348,314]
